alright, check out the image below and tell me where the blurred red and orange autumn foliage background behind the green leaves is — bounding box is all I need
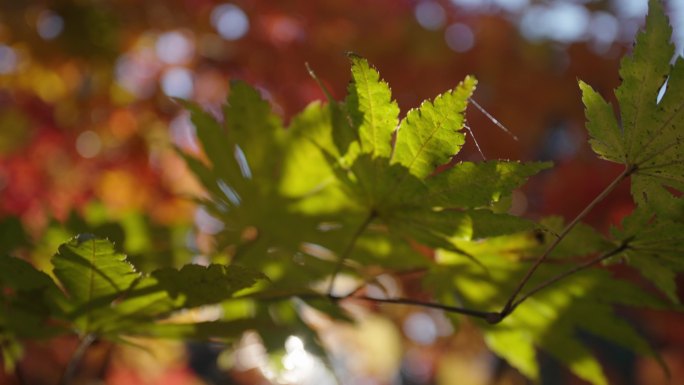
[0,0,684,385]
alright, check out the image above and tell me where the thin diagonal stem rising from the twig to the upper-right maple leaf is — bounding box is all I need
[500,165,637,319]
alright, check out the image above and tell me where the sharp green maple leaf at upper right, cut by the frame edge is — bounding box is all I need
[580,0,684,215]
